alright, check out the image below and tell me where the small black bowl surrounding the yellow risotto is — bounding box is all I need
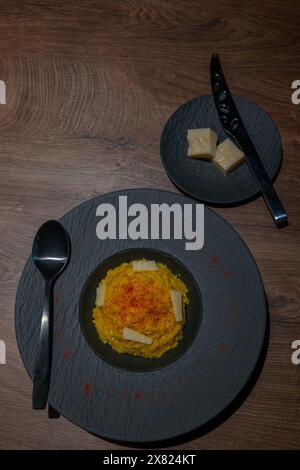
[79,248,202,372]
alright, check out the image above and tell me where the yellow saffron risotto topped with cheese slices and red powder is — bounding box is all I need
[93,260,189,358]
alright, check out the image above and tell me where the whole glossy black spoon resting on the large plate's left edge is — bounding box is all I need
[32,220,70,410]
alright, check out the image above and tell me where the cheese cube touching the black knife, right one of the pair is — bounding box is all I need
[212,139,245,175]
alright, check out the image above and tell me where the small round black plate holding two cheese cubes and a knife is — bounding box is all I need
[160,95,282,206]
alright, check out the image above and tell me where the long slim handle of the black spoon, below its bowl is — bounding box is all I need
[32,280,53,410]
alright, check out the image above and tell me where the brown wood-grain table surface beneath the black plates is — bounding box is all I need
[0,0,300,449]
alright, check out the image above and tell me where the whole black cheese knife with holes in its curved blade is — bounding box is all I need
[210,54,287,226]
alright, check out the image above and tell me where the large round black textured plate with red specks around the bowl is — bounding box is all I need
[15,189,266,443]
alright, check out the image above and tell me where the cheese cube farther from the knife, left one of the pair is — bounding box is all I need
[187,128,218,160]
